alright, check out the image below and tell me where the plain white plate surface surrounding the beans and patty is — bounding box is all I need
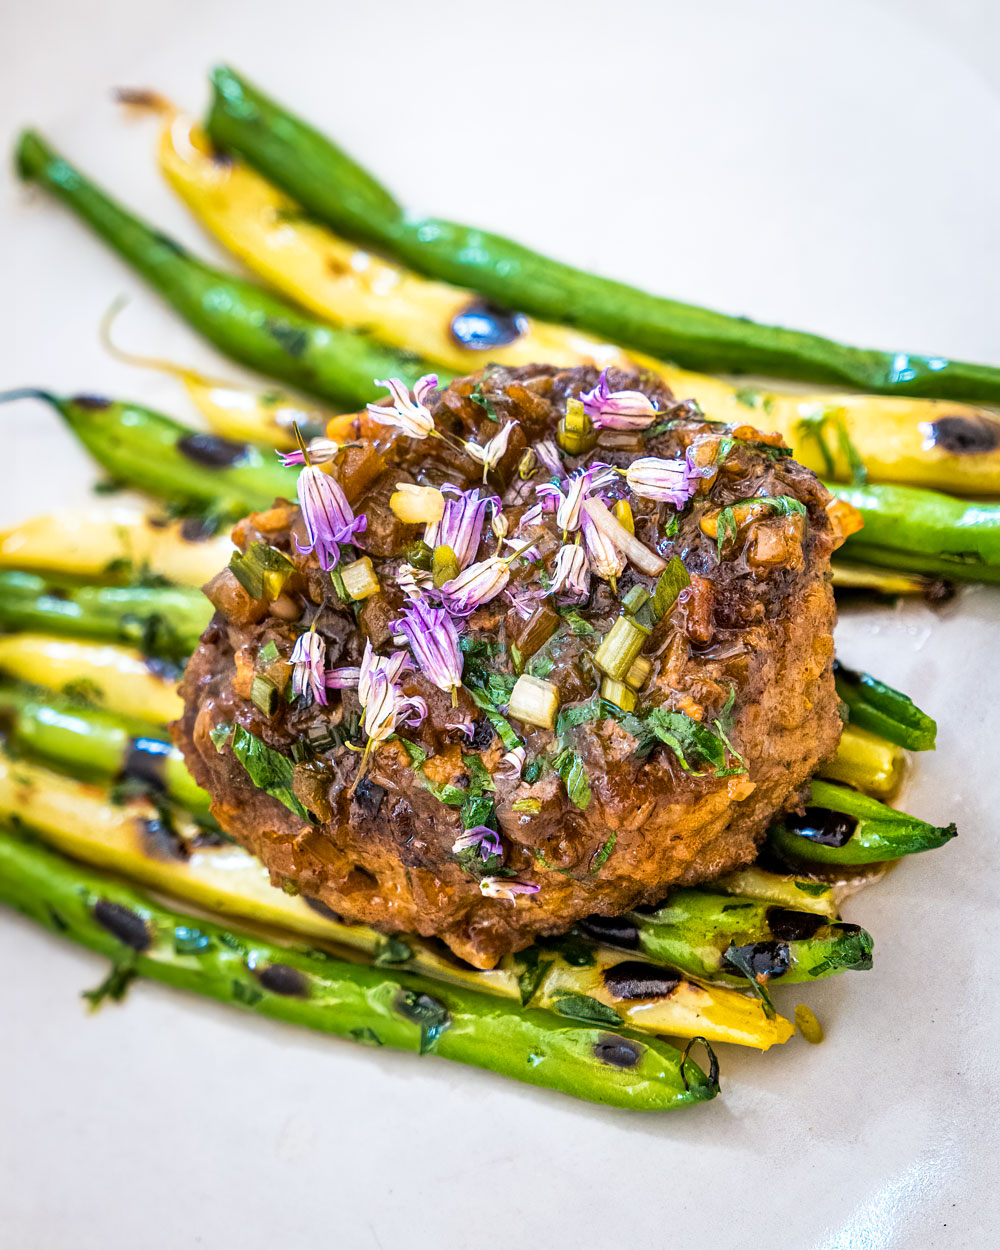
[0,0,1000,1250]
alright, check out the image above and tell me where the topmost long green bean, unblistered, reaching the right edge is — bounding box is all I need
[208,68,1000,401]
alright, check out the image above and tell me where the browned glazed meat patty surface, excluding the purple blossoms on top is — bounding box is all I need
[174,365,841,968]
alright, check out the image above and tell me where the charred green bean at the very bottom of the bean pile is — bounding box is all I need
[0,830,719,1111]
